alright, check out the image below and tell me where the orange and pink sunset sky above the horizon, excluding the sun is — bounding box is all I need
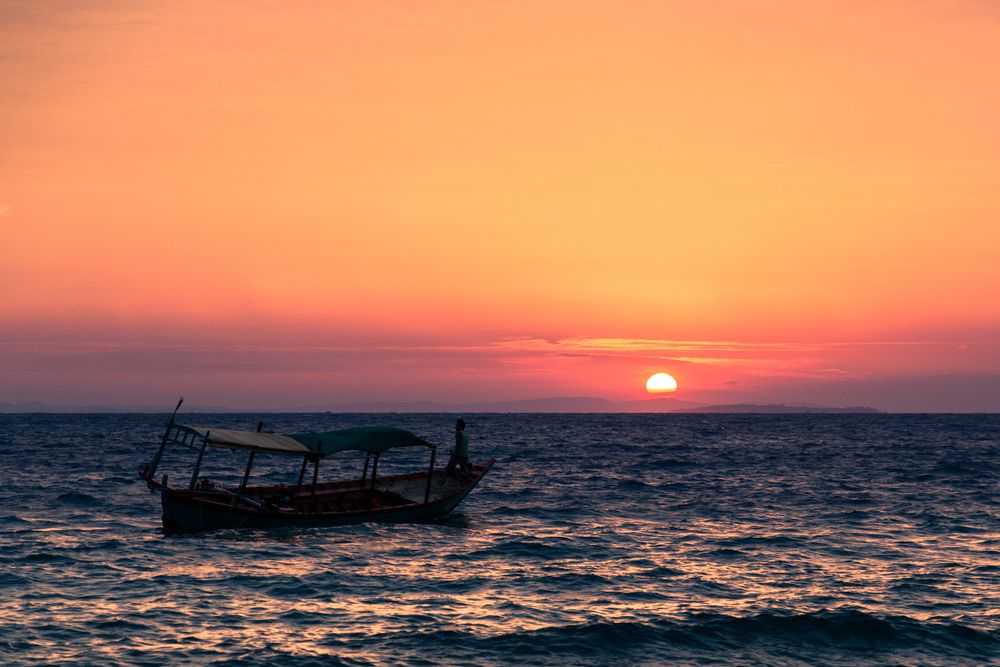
[0,0,1000,411]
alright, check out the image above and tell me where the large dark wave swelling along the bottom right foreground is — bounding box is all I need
[346,610,1000,665]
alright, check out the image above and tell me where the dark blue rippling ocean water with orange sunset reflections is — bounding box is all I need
[0,414,1000,665]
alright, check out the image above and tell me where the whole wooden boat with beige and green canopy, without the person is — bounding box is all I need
[139,411,494,532]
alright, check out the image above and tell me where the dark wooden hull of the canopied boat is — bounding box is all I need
[158,459,494,532]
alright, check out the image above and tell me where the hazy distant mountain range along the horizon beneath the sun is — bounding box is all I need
[0,396,879,414]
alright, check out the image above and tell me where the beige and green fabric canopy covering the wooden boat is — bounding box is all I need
[175,424,435,456]
